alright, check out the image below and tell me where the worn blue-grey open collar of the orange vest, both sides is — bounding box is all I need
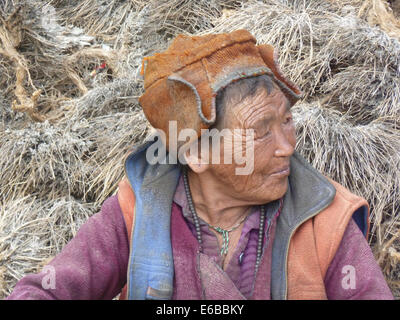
[125,141,336,300]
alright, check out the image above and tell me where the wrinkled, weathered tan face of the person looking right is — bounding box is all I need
[209,87,296,204]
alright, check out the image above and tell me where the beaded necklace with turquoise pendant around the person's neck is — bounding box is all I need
[183,168,265,272]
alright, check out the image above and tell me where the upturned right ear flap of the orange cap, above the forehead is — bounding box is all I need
[257,44,303,105]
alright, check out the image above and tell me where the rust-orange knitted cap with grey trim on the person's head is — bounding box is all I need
[139,30,302,145]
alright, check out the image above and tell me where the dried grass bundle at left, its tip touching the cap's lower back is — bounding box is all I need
[0,106,148,201]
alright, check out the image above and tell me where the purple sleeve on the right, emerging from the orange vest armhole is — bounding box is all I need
[325,219,393,300]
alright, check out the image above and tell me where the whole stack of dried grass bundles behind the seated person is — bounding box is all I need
[0,0,400,298]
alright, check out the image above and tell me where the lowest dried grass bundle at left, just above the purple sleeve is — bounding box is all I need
[0,195,99,299]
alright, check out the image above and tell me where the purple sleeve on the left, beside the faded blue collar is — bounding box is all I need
[7,195,129,300]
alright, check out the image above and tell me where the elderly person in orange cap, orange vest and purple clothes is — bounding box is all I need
[9,30,393,299]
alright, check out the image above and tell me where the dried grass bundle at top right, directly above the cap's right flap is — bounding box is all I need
[205,0,400,123]
